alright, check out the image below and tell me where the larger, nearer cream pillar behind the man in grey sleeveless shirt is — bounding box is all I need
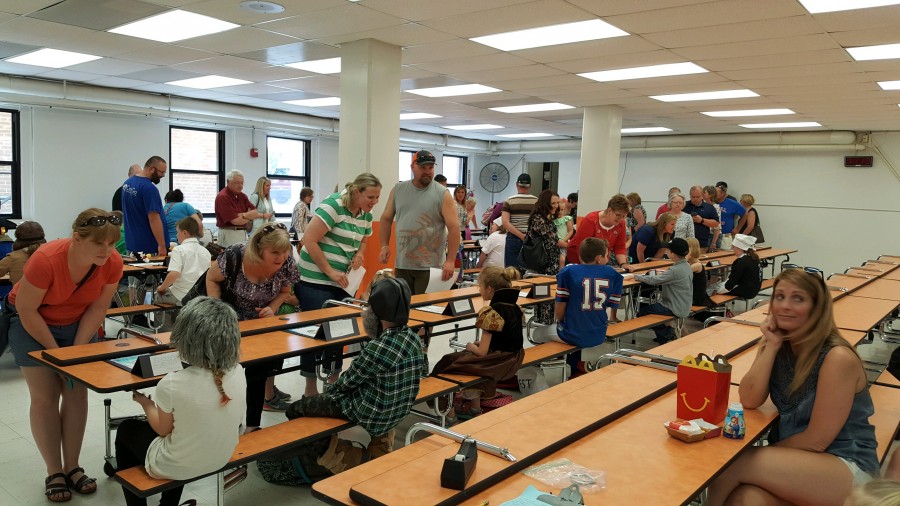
[338,39,400,216]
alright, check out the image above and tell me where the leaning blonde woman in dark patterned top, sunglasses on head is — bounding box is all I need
[206,223,300,431]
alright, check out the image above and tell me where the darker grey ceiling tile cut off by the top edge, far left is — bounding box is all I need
[29,0,169,30]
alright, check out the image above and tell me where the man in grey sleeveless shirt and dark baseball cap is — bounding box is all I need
[378,150,460,295]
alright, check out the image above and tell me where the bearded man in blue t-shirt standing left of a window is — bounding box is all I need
[122,156,169,256]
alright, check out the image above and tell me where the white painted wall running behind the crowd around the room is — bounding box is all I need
[8,102,900,272]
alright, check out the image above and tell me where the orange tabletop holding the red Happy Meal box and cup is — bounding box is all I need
[462,387,778,506]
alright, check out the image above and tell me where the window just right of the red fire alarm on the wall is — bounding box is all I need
[266,137,310,216]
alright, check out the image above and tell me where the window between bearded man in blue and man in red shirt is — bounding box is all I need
[169,127,225,216]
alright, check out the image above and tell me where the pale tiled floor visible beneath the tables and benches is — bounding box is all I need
[0,298,892,506]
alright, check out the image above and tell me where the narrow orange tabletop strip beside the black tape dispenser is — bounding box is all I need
[350,367,675,504]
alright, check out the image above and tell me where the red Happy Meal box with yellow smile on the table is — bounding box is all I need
[676,353,731,424]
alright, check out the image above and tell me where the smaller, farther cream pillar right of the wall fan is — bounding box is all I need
[578,106,622,212]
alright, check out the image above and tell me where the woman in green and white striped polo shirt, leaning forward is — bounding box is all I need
[294,173,381,395]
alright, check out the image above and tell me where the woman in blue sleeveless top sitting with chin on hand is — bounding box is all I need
[708,269,878,506]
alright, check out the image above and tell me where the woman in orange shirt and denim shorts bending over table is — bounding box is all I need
[8,208,122,502]
